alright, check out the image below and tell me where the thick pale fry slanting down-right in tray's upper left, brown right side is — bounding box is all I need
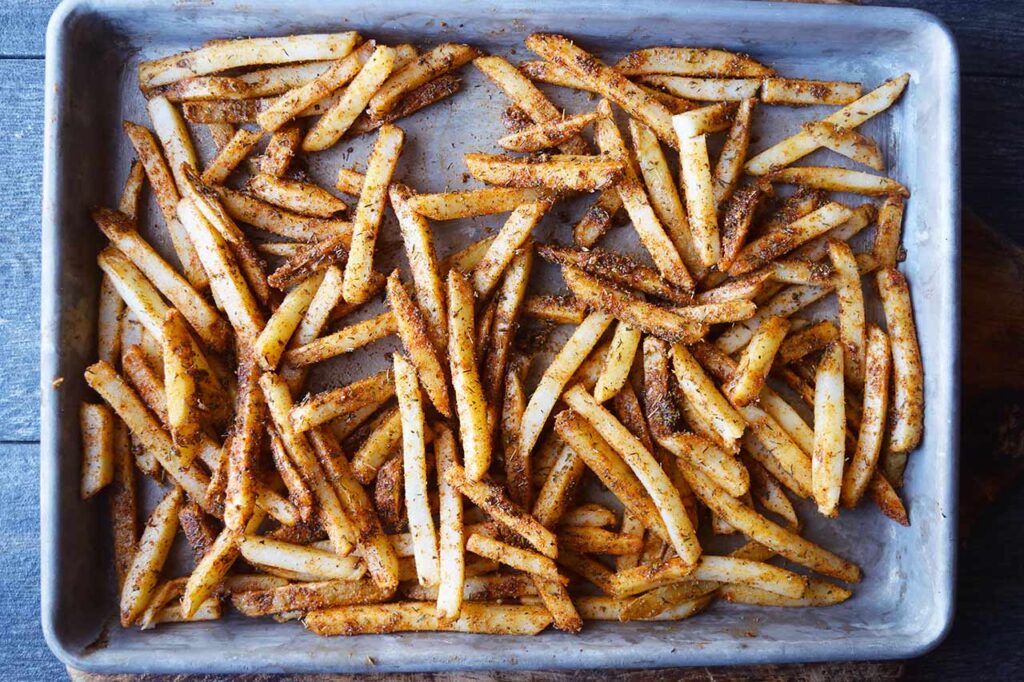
[178,199,265,346]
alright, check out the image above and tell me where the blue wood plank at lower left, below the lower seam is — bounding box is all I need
[0,444,63,680]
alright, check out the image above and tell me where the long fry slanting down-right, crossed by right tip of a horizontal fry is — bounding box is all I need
[594,100,693,289]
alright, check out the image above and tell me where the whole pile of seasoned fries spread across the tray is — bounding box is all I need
[80,33,924,635]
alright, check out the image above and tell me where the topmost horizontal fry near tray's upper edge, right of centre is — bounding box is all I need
[615,47,774,77]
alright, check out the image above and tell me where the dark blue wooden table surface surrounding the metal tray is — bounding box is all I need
[0,0,1024,680]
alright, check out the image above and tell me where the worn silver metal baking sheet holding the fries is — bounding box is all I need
[40,0,959,673]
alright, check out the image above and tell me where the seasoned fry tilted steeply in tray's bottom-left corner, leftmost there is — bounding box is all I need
[121,487,183,628]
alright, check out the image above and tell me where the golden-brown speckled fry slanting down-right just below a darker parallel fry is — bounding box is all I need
[562,266,707,343]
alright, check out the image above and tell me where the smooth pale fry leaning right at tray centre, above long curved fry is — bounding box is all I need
[519,312,612,457]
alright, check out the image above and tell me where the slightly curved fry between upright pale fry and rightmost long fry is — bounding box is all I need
[842,325,892,509]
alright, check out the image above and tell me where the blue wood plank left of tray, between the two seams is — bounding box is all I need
[0,59,43,441]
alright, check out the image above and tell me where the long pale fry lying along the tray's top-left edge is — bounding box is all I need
[138,31,359,89]
